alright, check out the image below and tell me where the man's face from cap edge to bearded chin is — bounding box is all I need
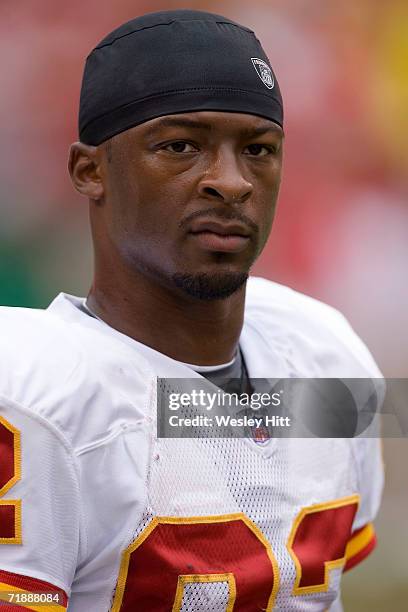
[101,111,283,299]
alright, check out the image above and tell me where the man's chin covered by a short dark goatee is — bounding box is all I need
[173,271,248,301]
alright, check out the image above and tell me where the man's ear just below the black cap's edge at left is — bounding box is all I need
[68,142,104,200]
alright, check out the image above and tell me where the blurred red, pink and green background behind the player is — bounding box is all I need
[0,0,408,612]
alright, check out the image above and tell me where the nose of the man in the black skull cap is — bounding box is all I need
[198,150,253,204]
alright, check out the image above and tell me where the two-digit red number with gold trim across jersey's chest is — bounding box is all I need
[112,495,359,612]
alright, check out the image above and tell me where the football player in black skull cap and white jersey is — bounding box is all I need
[0,11,382,612]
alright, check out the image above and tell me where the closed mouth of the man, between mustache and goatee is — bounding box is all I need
[189,220,250,253]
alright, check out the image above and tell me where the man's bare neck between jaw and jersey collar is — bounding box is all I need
[88,270,245,365]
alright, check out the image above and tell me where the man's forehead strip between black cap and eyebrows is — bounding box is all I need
[128,111,283,136]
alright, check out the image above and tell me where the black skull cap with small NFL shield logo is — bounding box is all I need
[79,10,283,145]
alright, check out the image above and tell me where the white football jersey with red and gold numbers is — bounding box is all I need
[0,278,382,612]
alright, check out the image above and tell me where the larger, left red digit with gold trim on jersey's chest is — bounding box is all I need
[112,514,279,612]
